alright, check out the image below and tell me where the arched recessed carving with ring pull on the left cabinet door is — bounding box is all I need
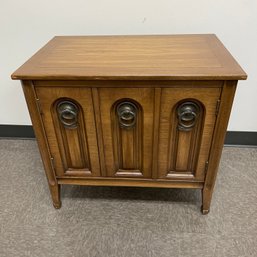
[52,98,91,176]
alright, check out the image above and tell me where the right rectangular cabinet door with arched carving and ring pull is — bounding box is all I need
[158,88,220,181]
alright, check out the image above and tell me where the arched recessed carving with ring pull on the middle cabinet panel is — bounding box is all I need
[111,99,143,176]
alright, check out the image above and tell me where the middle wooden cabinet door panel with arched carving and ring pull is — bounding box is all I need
[98,88,154,177]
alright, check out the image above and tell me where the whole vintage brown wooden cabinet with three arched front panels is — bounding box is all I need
[12,35,247,213]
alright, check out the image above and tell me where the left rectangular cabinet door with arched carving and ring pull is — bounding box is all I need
[36,86,100,177]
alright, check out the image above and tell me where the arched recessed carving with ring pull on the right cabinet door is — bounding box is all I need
[169,99,205,174]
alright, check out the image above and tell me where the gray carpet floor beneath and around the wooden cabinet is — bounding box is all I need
[0,139,257,257]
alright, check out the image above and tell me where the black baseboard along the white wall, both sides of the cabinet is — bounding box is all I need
[0,125,257,146]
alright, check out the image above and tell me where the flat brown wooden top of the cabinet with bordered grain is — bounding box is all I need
[12,34,247,80]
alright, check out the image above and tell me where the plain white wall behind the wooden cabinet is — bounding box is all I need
[0,0,257,131]
